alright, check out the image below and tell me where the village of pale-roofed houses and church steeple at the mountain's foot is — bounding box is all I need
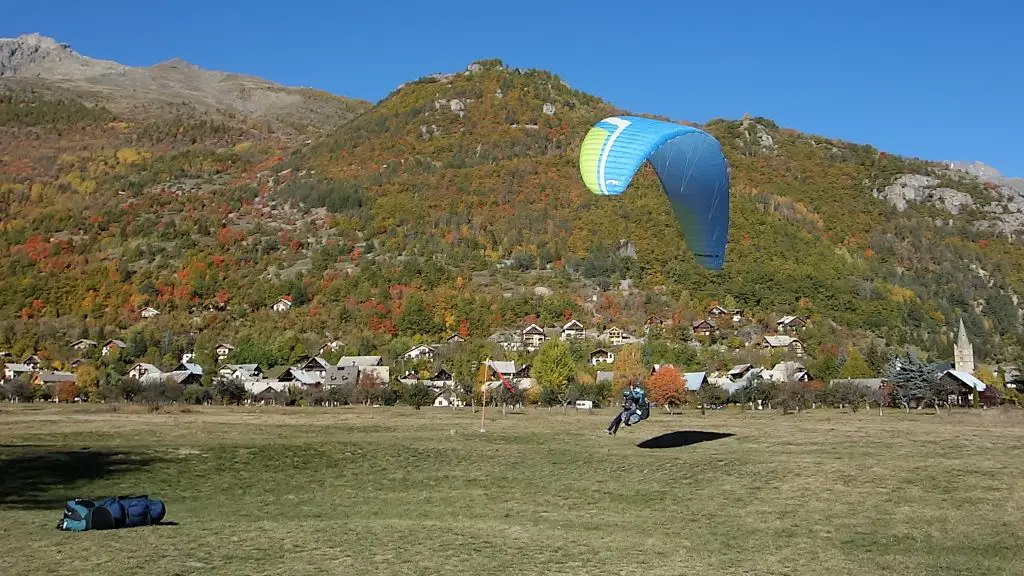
[0,298,1007,408]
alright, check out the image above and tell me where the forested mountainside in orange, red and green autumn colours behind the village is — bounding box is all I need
[0,42,1024,377]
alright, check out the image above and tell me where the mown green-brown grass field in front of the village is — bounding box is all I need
[0,405,1024,576]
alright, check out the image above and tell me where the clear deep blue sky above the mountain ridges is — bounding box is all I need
[8,0,1024,176]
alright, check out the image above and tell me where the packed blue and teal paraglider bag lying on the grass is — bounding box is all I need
[57,496,167,532]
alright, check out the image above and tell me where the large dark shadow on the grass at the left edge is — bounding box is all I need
[0,445,158,508]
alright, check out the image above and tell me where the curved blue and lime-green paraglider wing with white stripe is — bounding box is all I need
[580,116,729,271]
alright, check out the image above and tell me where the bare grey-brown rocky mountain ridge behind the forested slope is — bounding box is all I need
[0,34,369,130]
